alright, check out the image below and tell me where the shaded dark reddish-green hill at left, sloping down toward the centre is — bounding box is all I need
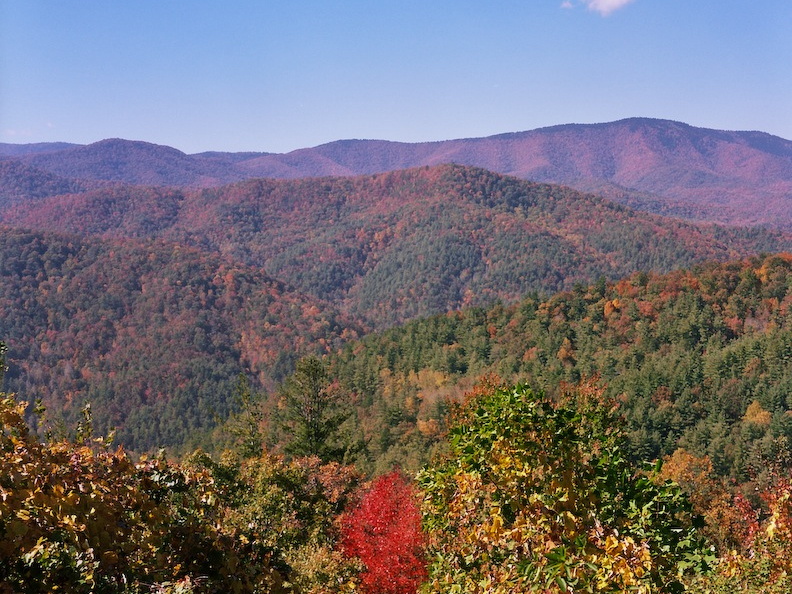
[0,228,358,450]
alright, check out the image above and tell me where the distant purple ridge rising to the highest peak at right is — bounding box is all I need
[240,118,792,226]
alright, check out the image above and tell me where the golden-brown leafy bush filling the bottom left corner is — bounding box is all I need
[0,396,284,594]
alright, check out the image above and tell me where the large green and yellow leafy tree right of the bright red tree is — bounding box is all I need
[419,387,711,593]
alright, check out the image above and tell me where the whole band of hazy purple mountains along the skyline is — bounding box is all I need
[6,118,792,228]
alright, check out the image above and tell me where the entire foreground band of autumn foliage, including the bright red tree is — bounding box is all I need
[0,354,792,594]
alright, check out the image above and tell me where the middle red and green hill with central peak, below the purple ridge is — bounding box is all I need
[0,165,792,328]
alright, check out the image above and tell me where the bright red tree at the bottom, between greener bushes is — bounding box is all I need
[342,470,427,594]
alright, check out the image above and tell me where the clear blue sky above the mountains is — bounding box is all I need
[0,0,792,152]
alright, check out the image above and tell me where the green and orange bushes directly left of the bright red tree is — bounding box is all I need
[195,453,361,594]
